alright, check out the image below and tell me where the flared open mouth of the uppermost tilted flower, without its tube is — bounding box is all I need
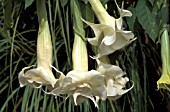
[85,21,136,58]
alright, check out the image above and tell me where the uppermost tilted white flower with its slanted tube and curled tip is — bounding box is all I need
[83,0,135,58]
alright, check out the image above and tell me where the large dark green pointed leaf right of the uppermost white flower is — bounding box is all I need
[136,0,159,41]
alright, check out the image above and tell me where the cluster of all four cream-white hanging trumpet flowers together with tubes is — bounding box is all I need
[18,0,135,107]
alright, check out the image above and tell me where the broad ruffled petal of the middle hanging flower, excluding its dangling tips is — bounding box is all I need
[50,70,106,99]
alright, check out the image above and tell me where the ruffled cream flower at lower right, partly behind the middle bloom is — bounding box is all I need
[96,59,133,100]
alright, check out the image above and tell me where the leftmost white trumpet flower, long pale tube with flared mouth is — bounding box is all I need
[18,20,57,88]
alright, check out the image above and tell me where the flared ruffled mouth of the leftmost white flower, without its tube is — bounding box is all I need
[18,66,57,87]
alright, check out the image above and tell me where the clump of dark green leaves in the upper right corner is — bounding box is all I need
[126,0,168,42]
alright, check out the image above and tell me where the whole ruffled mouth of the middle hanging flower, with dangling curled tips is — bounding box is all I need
[50,70,106,107]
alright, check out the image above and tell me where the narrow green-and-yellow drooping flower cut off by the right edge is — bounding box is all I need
[157,29,170,91]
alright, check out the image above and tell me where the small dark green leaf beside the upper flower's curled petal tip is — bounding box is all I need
[126,6,136,32]
